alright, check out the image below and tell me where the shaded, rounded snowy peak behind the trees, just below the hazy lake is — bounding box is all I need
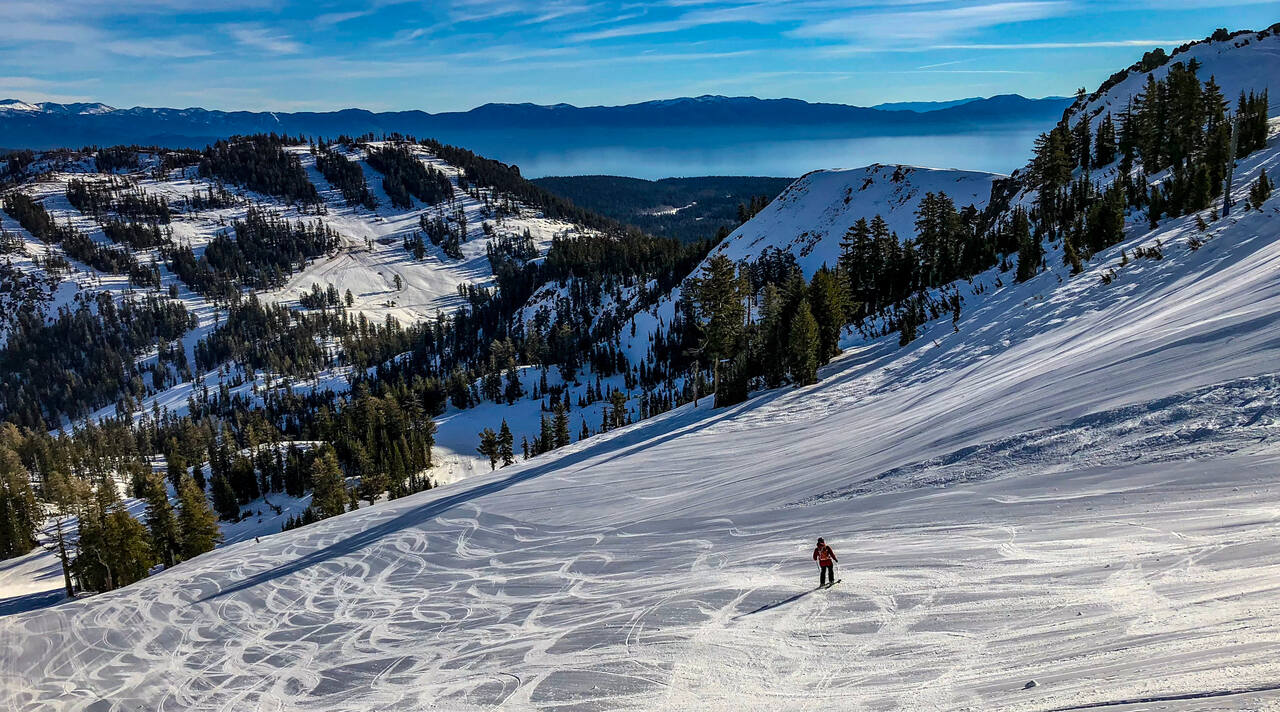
[712,164,1002,277]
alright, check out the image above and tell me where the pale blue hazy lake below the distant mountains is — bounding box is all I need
[424,125,1042,179]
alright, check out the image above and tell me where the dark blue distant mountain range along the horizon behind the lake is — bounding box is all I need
[0,95,1071,149]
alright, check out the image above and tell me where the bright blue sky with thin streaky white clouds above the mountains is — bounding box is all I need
[0,0,1280,111]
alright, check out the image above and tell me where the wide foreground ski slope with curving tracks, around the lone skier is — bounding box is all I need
[0,121,1280,712]
